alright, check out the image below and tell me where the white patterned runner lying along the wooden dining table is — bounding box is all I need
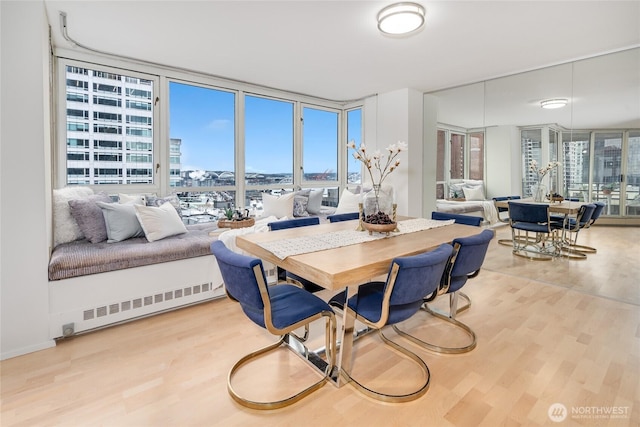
[258,218,455,259]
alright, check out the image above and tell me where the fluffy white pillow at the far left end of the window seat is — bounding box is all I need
[53,187,93,247]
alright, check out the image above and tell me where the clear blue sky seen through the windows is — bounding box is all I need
[169,82,360,173]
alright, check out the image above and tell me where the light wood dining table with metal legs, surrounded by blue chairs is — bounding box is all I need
[236,218,481,386]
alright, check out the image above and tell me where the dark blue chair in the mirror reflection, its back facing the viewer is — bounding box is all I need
[509,201,560,261]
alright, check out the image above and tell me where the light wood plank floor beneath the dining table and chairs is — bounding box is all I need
[0,227,640,427]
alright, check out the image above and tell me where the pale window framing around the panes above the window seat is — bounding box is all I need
[52,49,352,214]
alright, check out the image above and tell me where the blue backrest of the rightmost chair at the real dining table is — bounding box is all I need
[445,230,494,292]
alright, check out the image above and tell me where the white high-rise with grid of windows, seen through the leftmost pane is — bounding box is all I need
[66,66,160,185]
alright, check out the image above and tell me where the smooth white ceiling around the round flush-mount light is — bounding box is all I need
[44,0,640,129]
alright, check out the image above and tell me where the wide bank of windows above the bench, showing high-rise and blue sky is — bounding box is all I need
[54,58,362,223]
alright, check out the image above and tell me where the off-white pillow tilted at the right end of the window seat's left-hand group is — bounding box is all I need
[133,202,187,242]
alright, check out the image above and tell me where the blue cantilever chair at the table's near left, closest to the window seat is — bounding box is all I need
[211,240,336,409]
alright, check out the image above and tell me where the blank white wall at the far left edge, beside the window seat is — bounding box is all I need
[0,1,54,359]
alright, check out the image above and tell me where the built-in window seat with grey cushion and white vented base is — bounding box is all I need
[49,223,224,339]
